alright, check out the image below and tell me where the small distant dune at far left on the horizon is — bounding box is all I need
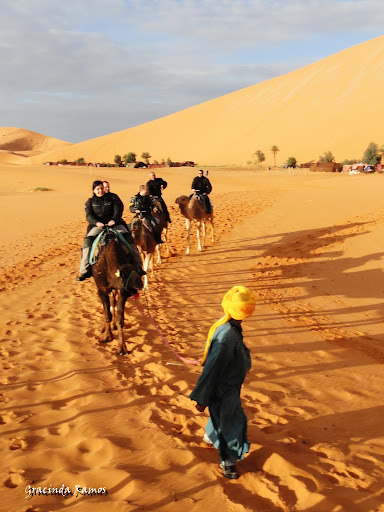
[0,126,71,156]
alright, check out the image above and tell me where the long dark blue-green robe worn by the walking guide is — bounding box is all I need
[189,319,251,460]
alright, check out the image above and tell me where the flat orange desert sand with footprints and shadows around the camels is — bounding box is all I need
[0,162,384,512]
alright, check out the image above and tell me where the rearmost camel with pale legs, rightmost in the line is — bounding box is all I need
[175,194,215,254]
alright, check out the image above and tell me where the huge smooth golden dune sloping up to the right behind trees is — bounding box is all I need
[27,36,384,165]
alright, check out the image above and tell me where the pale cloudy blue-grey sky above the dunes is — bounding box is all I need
[0,0,384,142]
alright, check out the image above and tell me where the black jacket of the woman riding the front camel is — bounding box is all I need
[85,193,124,233]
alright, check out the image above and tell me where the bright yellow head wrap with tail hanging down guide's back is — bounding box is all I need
[201,286,256,364]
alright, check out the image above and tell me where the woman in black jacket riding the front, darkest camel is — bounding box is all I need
[77,180,145,281]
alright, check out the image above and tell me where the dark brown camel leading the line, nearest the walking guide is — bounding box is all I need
[92,228,143,355]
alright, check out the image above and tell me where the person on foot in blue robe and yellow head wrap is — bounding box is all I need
[189,286,256,479]
